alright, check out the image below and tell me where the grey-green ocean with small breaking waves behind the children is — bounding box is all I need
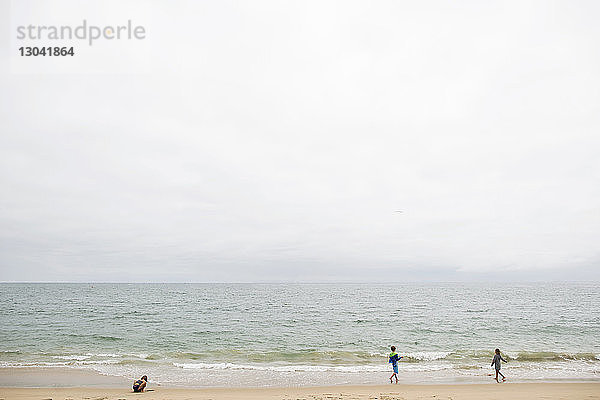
[0,283,600,387]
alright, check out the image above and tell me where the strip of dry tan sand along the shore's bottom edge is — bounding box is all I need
[0,383,600,400]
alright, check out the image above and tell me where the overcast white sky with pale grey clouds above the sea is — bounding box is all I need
[0,0,600,282]
